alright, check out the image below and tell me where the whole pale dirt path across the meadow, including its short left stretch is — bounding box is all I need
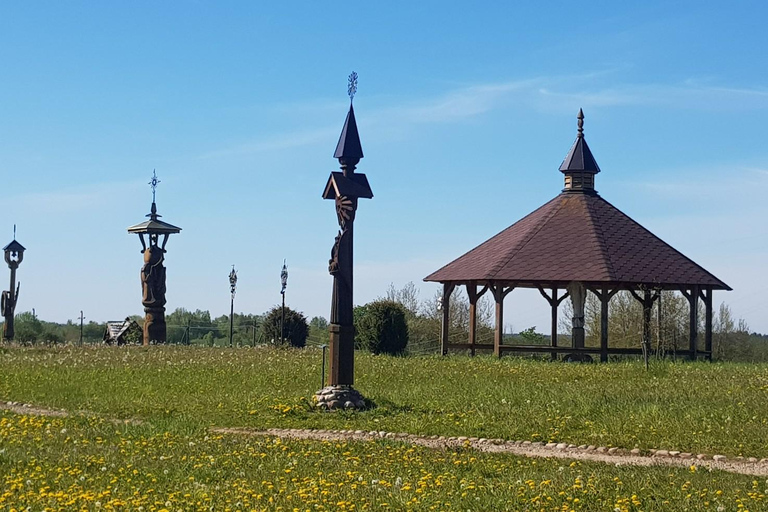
[0,400,768,477]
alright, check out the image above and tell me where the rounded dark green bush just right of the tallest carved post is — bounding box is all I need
[355,300,408,355]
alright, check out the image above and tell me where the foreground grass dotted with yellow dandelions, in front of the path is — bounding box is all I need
[0,412,768,512]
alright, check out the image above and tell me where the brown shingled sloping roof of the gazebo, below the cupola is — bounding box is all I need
[424,192,731,290]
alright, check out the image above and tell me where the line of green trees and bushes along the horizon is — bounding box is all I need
[4,282,768,361]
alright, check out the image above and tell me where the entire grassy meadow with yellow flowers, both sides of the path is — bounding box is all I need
[0,346,768,512]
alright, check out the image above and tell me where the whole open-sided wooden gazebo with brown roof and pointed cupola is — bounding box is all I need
[424,110,731,361]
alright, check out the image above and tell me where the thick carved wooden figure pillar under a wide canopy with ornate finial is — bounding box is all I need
[128,171,181,345]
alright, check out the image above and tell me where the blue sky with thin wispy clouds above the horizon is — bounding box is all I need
[0,1,768,332]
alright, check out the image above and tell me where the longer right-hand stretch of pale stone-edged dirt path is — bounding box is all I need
[211,428,768,477]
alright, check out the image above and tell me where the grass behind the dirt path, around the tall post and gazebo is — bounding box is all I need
[0,346,768,457]
